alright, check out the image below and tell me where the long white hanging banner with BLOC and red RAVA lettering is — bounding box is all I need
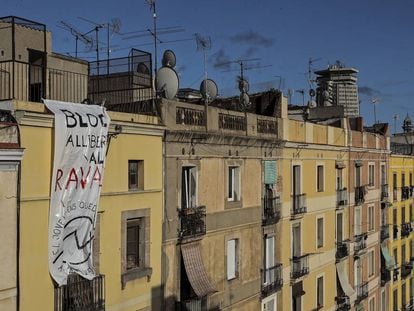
[44,100,110,286]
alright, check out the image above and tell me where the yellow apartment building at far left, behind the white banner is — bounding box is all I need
[0,17,164,310]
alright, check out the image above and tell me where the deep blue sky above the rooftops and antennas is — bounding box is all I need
[2,0,414,129]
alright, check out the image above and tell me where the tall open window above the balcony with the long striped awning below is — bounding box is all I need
[181,166,197,208]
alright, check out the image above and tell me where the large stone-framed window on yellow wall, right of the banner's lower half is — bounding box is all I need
[121,209,152,289]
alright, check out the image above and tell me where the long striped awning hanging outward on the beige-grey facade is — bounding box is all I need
[181,242,216,298]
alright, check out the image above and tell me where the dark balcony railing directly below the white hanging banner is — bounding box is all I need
[54,274,105,311]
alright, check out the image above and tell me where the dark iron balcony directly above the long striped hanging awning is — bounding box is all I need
[178,206,206,239]
